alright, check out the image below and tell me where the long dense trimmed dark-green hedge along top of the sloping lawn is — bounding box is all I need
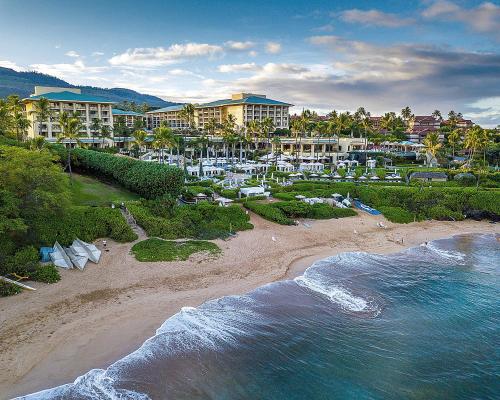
[66,148,184,199]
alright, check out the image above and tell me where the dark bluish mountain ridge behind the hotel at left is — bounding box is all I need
[0,67,178,108]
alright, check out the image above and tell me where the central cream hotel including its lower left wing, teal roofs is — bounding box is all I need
[146,93,293,130]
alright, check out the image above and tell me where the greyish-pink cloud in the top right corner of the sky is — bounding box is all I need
[422,0,500,37]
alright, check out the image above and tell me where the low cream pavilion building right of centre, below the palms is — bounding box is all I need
[272,137,368,162]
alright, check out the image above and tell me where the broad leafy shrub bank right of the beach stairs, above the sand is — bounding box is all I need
[127,201,253,239]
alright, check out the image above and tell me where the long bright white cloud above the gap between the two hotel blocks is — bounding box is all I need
[108,43,223,67]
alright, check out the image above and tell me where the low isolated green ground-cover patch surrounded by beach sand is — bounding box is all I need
[132,238,221,261]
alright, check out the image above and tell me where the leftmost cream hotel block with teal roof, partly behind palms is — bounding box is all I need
[23,86,114,141]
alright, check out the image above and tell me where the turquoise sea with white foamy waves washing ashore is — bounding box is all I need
[21,235,500,400]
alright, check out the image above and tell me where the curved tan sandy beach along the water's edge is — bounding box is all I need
[0,213,500,399]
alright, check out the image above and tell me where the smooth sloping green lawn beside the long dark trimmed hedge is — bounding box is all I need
[71,174,139,206]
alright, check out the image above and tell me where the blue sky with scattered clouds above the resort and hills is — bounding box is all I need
[0,0,500,127]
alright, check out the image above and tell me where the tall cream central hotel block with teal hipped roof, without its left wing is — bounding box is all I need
[195,93,293,129]
